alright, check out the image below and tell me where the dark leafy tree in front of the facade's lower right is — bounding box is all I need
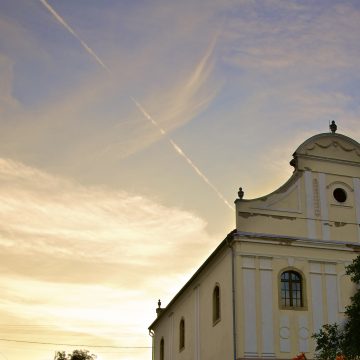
[313,255,360,360]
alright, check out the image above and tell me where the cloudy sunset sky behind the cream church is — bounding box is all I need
[0,0,360,360]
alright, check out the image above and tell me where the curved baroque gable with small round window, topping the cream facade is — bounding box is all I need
[236,129,360,243]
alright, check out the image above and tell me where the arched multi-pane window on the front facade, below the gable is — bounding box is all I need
[280,270,304,308]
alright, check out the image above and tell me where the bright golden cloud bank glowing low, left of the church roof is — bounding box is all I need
[0,158,217,360]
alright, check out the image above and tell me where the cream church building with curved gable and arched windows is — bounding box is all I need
[149,133,360,360]
